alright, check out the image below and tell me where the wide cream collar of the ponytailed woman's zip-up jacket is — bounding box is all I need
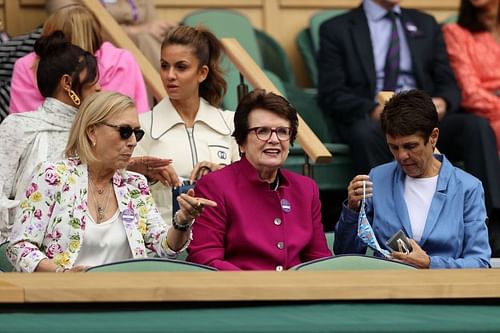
[151,97,232,139]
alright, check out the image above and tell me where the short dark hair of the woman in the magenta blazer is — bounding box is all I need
[233,89,299,146]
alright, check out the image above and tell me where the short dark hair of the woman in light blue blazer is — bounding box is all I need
[380,90,438,142]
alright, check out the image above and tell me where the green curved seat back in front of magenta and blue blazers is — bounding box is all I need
[292,255,417,271]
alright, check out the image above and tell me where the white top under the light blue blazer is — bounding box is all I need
[404,175,438,242]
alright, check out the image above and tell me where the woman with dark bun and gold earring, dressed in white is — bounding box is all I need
[0,31,101,243]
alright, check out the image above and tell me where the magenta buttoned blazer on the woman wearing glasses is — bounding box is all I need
[187,157,332,271]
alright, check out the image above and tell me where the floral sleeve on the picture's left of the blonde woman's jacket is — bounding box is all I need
[7,163,60,272]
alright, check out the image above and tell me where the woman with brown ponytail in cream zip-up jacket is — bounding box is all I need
[136,26,239,221]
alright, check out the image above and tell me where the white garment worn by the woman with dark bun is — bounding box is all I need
[0,97,78,243]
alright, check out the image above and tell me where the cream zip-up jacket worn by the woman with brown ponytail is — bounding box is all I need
[134,97,240,224]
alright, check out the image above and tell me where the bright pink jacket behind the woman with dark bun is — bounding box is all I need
[9,42,149,113]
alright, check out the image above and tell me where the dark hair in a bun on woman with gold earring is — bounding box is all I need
[35,30,99,97]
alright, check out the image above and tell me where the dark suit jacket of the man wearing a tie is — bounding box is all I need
[318,6,460,124]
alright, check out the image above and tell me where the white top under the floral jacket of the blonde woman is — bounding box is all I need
[73,209,132,266]
